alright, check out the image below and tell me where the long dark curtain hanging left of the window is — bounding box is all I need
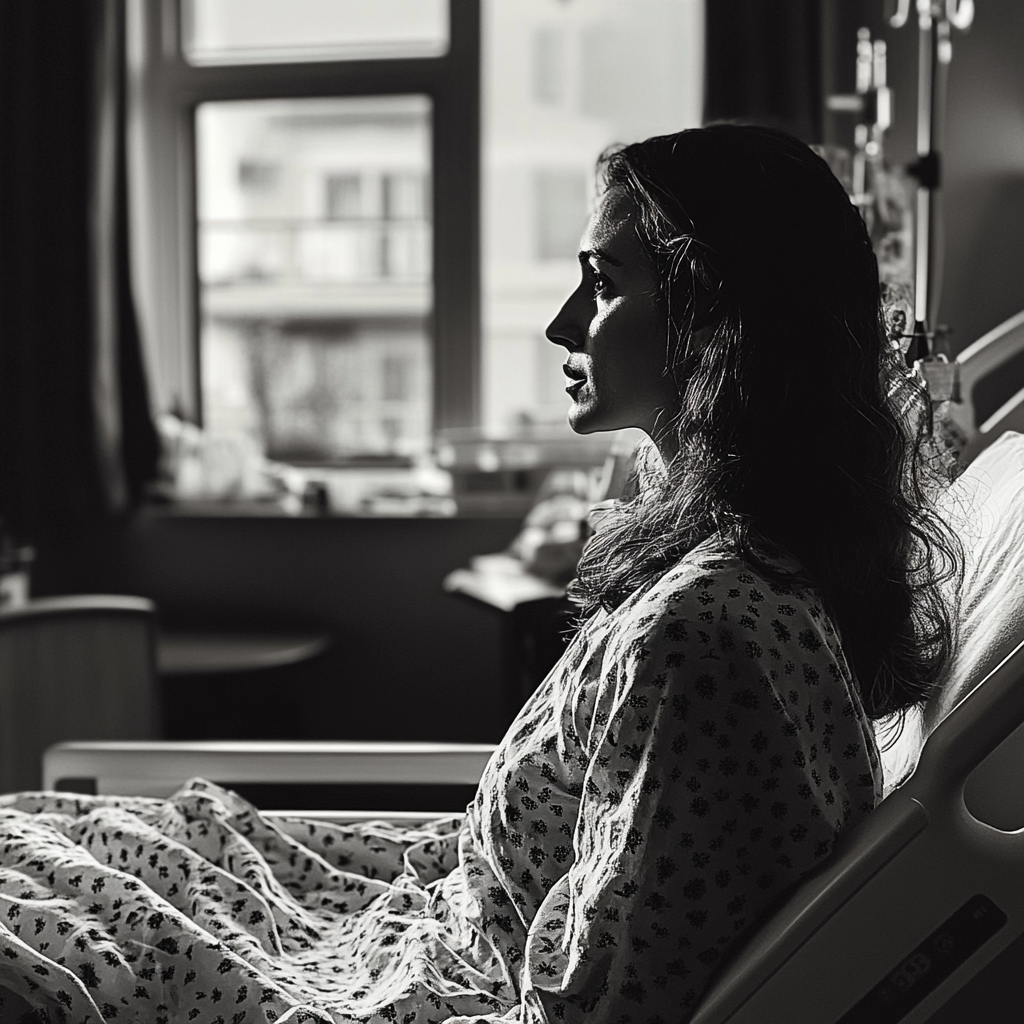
[0,0,159,541]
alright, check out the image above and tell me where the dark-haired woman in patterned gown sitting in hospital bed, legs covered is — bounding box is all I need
[0,125,955,1022]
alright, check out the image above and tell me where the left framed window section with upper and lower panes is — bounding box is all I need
[129,0,480,464]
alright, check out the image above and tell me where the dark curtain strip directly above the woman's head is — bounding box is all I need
[705,0,822,142]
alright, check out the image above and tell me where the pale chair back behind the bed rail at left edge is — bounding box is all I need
[0,595,156,793]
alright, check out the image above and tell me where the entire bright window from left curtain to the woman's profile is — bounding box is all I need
[130,0,702,495]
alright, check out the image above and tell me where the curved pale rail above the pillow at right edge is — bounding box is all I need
[945,310,1024,462]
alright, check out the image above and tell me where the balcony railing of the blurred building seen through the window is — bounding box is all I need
[199,218,431,285]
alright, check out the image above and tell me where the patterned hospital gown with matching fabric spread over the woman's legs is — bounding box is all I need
[0,542,881,1024]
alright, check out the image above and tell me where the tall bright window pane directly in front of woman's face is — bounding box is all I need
[482,0,703,436]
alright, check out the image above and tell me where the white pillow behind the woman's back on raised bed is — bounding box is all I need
[879,431,1024,794]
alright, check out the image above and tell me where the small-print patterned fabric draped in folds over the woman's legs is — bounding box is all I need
[0,780,491,1024]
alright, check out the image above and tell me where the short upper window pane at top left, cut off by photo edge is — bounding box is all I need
[182,0,449,63]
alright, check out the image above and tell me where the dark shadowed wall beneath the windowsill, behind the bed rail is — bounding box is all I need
[34,511,518,742]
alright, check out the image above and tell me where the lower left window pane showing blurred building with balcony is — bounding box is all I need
[196,96,432,463]
